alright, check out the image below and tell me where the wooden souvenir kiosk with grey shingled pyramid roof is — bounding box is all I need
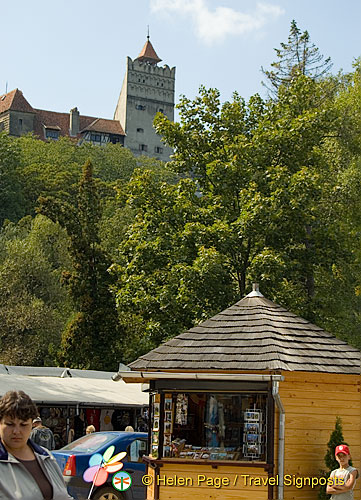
[115,285,361,500]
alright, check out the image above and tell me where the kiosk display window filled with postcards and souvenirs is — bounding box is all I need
[158,393,267,462]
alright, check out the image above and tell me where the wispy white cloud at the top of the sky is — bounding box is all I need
[150,0,284,45]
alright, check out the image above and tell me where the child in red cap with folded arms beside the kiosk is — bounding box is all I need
[326,444,358,500]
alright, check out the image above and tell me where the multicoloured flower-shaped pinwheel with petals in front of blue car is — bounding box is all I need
[83,446,127,489]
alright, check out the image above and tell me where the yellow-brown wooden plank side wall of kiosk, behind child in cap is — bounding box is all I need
[275,372,361,500]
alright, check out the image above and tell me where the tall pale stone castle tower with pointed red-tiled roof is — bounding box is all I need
[114,35,175,161]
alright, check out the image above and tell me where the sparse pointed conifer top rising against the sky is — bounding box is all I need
[262,20,332,95]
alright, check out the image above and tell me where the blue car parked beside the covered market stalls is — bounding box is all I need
[52,431,148,500]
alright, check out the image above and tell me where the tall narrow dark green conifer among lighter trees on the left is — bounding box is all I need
[38,161,121,370]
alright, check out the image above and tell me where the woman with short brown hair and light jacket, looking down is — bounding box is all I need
[0,391,72,500]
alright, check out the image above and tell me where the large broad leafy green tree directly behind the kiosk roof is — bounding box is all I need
[113,77,349,345]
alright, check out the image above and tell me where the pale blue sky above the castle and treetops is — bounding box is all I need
[0,0,361,118]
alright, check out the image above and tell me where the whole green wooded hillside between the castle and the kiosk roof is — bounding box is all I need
[0,21,361,371]
